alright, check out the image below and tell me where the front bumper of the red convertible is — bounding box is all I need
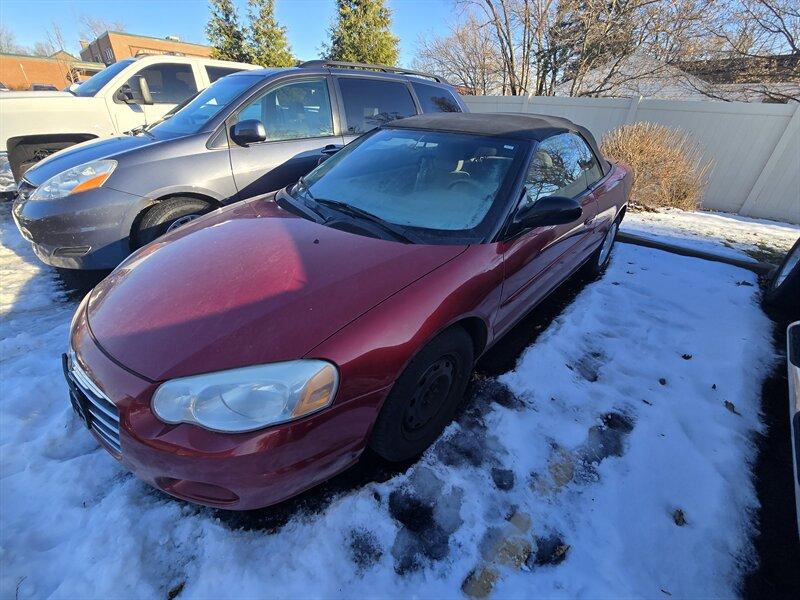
[65,314,388,510]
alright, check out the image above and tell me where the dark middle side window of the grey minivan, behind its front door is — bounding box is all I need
[339,77,417,134]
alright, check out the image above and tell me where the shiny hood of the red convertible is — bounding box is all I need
[87,196,466,381]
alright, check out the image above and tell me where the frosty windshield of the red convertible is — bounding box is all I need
[293,129,525,243]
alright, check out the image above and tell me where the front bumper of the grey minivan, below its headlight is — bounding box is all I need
[12,185,145,269]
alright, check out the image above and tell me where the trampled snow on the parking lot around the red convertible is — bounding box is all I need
[0,207,773,599]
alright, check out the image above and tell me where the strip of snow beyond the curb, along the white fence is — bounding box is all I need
[622,209,800,264]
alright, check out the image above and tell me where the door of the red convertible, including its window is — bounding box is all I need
[496,133,597,333]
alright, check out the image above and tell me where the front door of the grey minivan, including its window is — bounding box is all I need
[227,75,344,200]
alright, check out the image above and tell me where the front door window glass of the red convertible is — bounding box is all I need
[524,133,586,203]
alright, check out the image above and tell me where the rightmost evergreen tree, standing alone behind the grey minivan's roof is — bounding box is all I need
[323,0,399,66]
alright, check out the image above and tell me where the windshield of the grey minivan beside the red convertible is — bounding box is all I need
[153,75,262,135]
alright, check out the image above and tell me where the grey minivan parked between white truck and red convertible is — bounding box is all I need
[13,61,467,269]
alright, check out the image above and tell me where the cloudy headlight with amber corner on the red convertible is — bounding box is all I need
[152,360,339,433]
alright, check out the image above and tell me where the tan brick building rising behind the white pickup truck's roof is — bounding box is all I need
[81,31,211,65]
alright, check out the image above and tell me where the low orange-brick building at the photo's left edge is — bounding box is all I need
[0,50,105,90]
